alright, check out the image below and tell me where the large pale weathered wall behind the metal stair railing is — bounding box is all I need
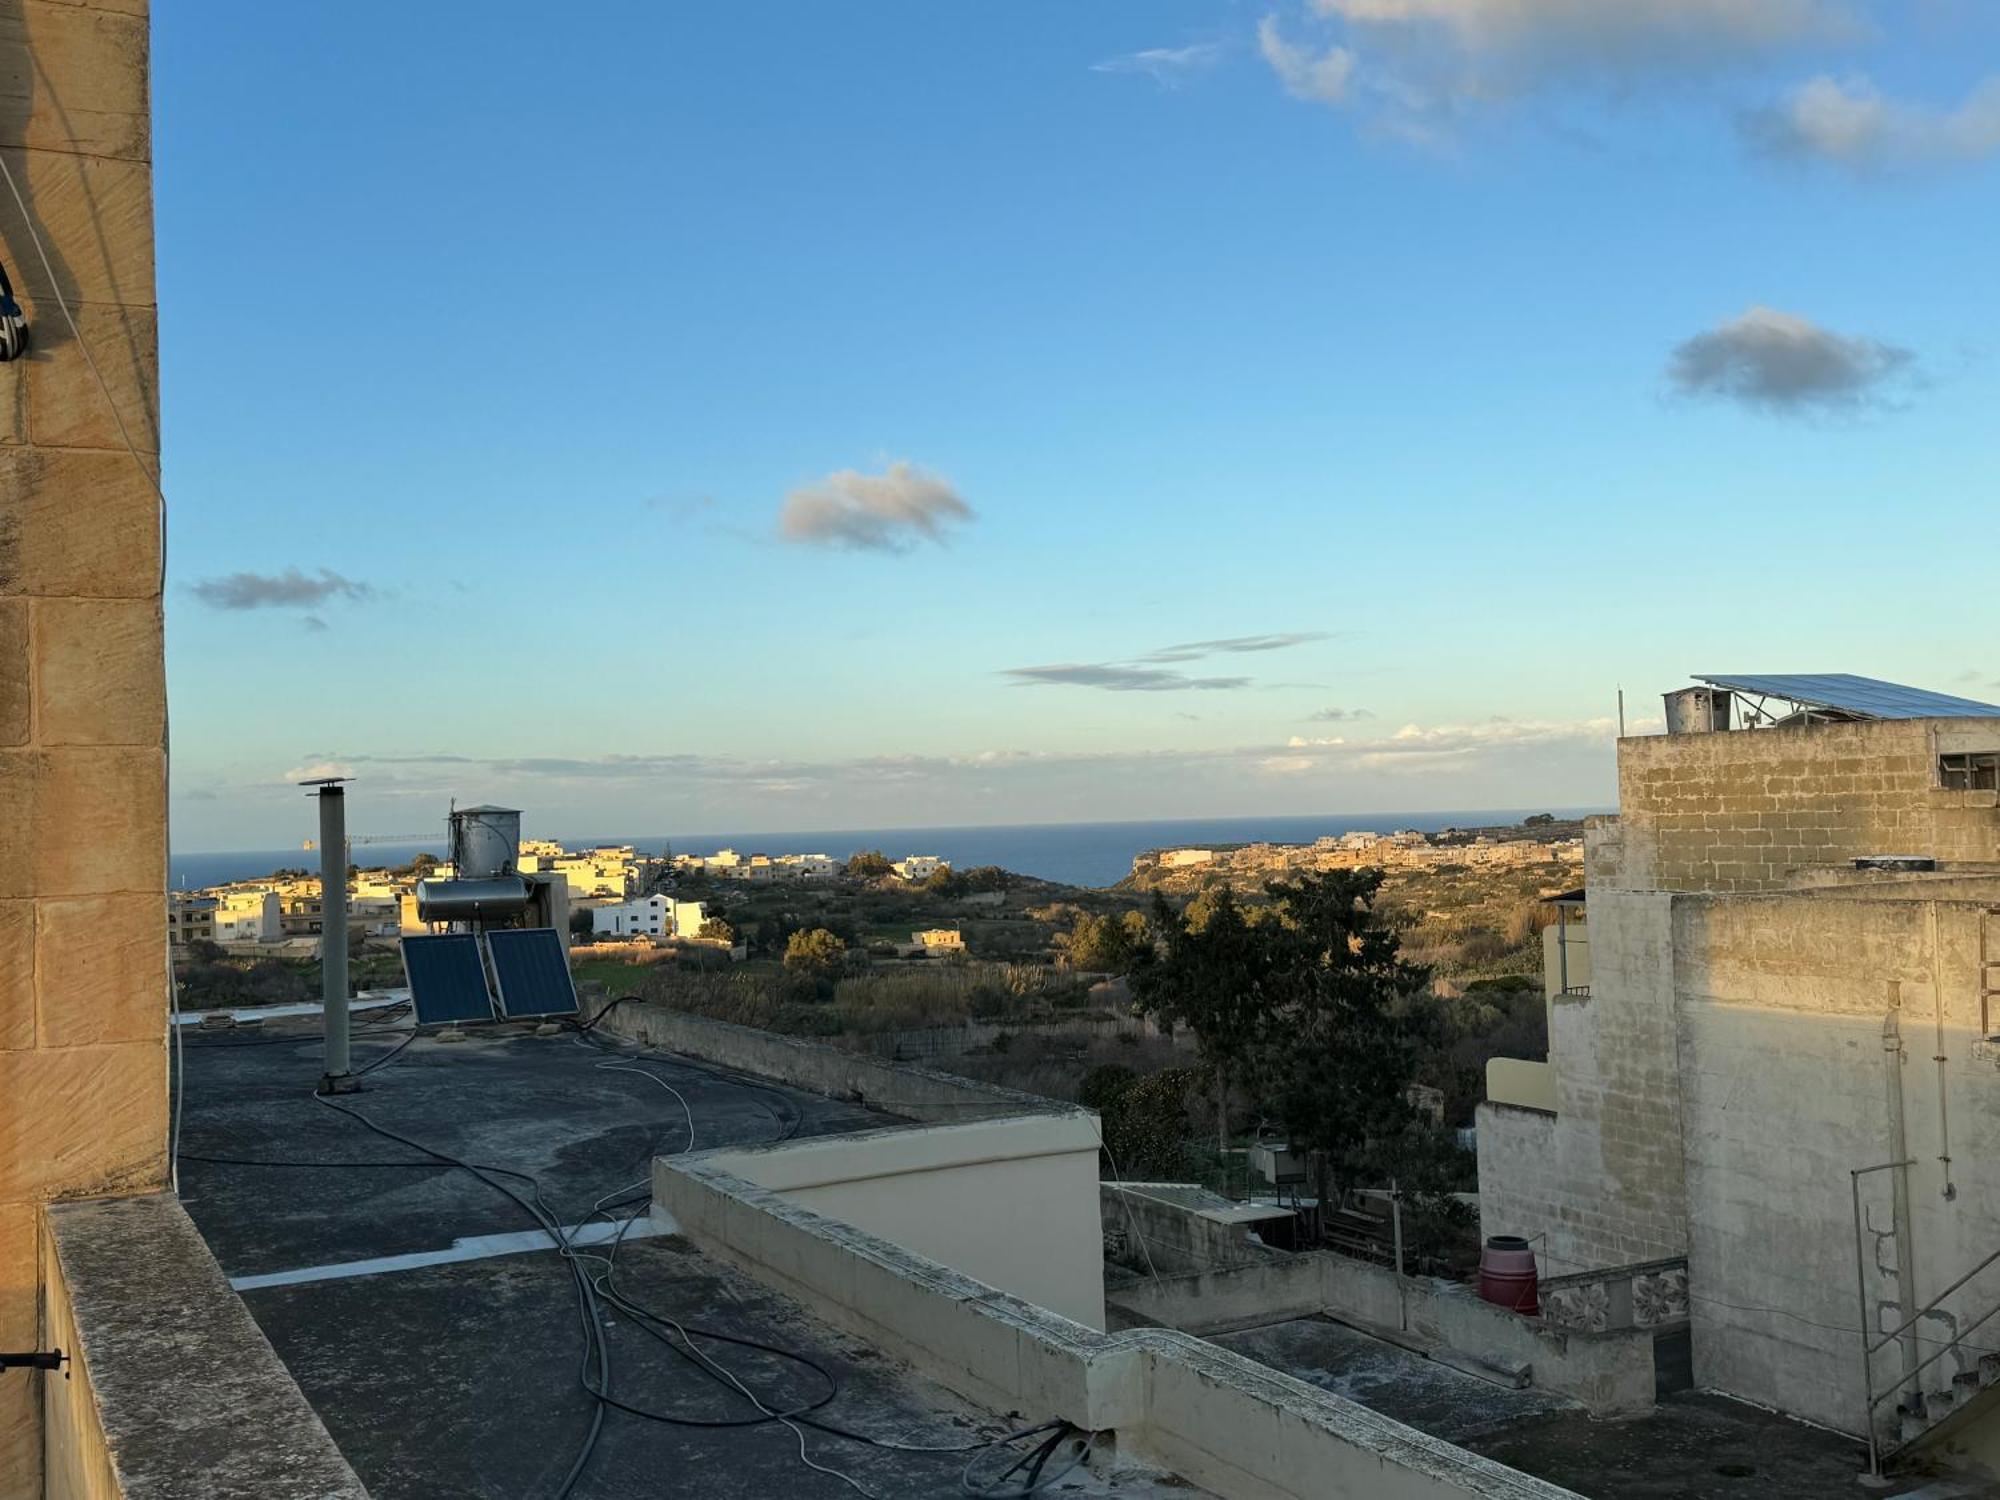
[1674,896,2000,1432]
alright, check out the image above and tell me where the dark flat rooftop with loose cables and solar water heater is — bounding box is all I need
[180,1018,1198,1500]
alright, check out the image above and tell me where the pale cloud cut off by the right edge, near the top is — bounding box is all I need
[1742,74,2000,174]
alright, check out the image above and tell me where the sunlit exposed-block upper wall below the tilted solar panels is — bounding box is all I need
[1590,718,2000,892]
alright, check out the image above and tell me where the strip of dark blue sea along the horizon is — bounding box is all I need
[170,808,1608,888]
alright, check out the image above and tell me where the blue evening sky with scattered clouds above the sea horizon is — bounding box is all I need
[154,0,2000,850]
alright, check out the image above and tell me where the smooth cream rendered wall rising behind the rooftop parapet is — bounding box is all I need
[706,1110,1104,1330]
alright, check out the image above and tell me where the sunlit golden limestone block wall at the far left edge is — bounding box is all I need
[0,0,166,1500]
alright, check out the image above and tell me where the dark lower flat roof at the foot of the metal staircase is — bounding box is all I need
[1212,1318,2000,1500]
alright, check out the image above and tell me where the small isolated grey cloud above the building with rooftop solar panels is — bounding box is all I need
[1666,306,1916,414]
